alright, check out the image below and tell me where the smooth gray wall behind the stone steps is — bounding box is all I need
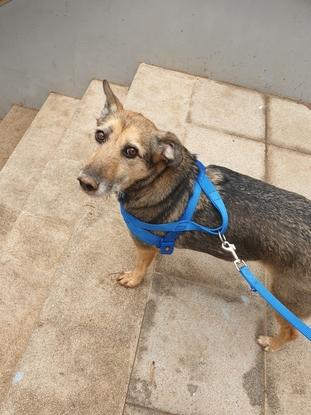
[0,0,311,116]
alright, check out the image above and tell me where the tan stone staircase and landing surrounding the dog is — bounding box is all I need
[0,64,311,415]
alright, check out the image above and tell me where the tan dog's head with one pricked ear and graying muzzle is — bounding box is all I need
[78,81,183,195]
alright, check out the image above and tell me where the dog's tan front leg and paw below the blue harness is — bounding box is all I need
[118,239,158,288]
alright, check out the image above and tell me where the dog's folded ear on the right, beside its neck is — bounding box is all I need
[153,131,183,167]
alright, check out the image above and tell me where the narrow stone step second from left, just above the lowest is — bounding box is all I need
[0,93,79,251]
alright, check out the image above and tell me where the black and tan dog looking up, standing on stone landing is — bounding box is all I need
[78,81,311,351]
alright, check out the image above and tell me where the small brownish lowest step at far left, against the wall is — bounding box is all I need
[0,105,38,170]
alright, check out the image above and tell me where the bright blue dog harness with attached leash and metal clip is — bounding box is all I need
[120,160,311,340]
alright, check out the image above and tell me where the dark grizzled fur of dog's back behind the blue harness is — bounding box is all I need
[214,166,311,274]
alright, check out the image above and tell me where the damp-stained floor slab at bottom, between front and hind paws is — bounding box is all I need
[128,274,264,415]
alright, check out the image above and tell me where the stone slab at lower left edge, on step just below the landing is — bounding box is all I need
[0,213,69,397]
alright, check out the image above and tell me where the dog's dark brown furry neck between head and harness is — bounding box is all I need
[124,149,198,223]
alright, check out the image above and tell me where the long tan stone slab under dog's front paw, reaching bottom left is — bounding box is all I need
[1,203,149,415]
